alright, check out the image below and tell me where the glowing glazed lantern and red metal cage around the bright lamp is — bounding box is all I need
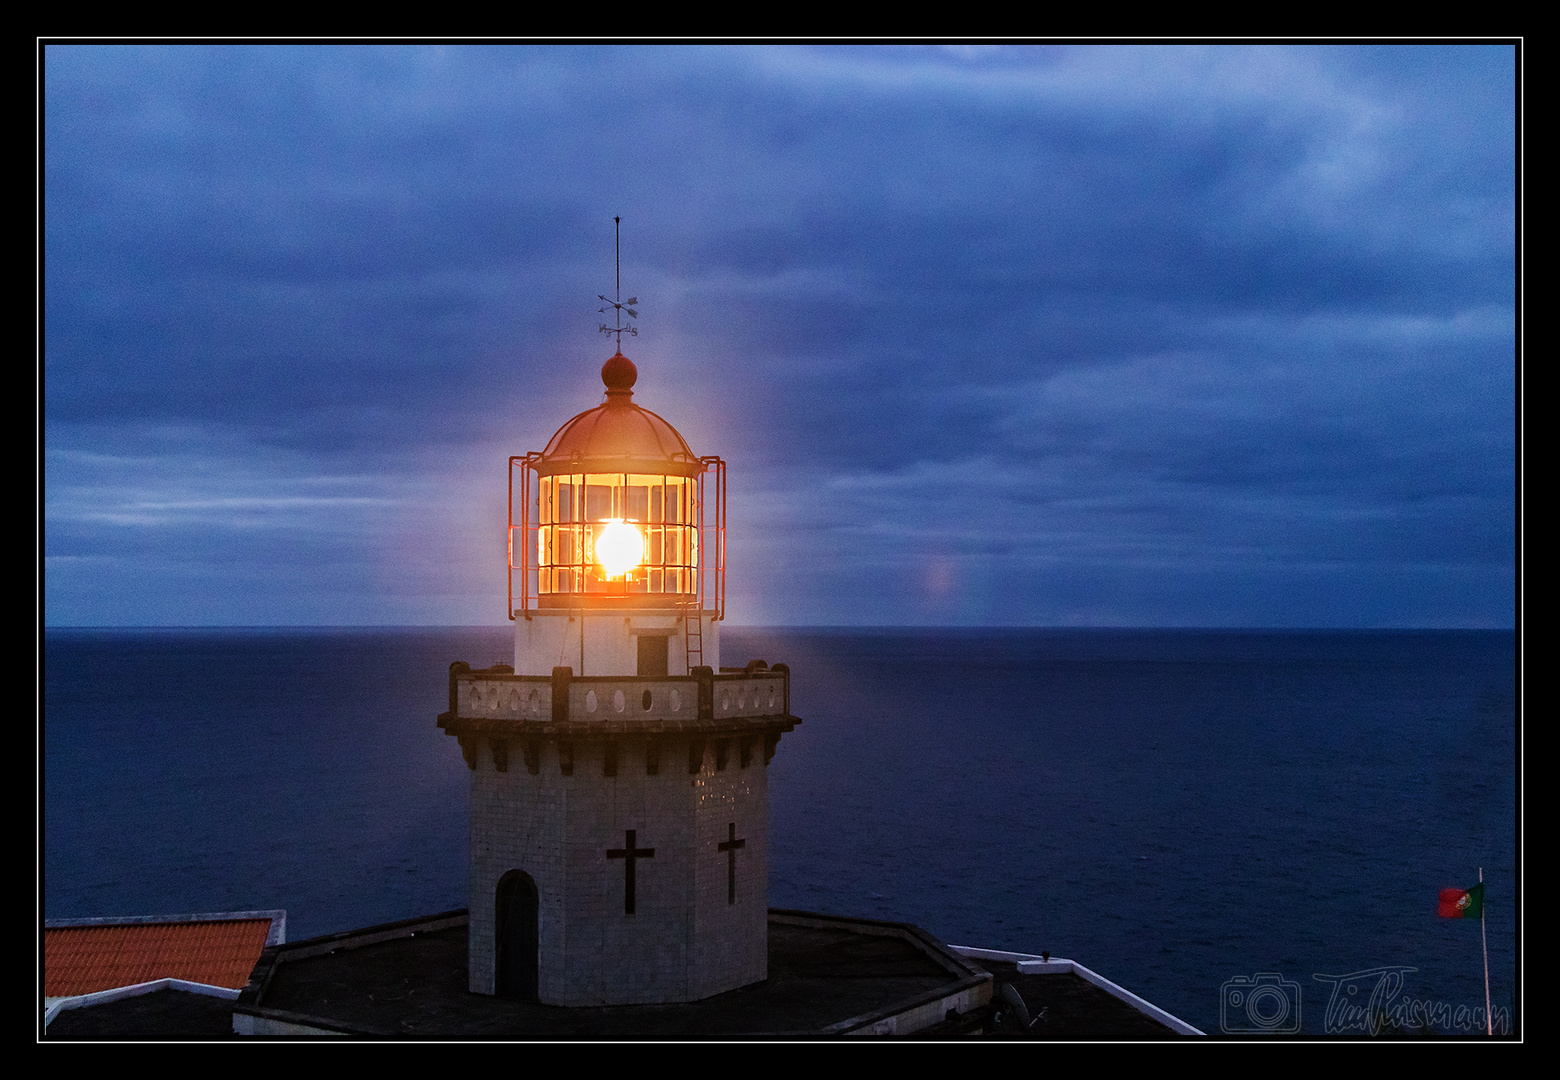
[509,453,725,620]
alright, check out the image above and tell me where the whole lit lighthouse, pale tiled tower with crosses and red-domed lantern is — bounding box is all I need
[438,349,800,1005]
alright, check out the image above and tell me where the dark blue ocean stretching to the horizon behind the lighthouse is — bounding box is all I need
[39,627,1521,1038]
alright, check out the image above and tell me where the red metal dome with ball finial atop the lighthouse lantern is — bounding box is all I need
[535,353,704,476]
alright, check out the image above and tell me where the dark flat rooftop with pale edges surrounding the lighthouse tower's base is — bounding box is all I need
[45,910,1178,1041]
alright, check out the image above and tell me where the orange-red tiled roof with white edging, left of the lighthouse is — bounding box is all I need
[44,919,271,997]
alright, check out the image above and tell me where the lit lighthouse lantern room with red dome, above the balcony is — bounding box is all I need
[509,351,725,676]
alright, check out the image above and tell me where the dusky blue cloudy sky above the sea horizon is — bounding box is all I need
[42,44,1518,627]
